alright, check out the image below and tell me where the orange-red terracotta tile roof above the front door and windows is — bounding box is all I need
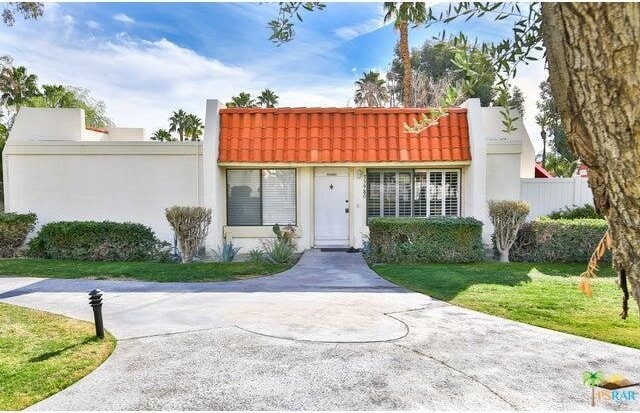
[218,108,471,163]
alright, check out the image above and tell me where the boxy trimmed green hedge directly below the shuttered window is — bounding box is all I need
[369,217,485,263]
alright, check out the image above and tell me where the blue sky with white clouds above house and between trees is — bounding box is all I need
[0,3,547,148]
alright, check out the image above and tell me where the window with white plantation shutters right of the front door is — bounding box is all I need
[367,169,460,217]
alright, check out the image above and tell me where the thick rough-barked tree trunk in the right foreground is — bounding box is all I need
[542,3,640,316]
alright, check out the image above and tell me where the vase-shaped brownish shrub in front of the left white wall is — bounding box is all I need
[165,206,211,263]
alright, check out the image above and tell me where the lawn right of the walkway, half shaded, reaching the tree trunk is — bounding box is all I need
[373,262,640,348]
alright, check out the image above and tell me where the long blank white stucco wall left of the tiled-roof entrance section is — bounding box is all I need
[4,142,202,242]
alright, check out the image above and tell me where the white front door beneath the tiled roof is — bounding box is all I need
[315,168,349,246]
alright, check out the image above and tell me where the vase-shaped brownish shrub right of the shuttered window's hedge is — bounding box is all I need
[489,200,529,262]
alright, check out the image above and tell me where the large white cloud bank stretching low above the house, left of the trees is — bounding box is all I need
[0,23,352,134]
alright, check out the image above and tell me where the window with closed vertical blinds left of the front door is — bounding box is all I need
[227,169,296,226]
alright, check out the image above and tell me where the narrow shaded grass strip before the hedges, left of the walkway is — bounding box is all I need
[0,258,291,282]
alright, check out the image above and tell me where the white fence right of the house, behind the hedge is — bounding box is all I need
[520,176,593,219]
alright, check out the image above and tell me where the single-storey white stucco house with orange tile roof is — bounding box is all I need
[3,99,535,252]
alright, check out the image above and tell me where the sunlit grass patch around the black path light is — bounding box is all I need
[0,303,116,410]
